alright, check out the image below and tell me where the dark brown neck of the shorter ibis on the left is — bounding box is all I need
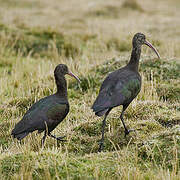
[56,76,67,97]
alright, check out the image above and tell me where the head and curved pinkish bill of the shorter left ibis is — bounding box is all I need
[54,64,80,82]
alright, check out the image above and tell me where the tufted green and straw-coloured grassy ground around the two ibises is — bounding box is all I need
[0,0,180,180]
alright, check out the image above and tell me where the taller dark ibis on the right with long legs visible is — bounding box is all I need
[92,33,160,151]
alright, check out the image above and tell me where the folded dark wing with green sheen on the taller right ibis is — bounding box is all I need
[92,71,141,112]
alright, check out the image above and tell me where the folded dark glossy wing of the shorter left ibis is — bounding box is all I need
[12,101,69,134]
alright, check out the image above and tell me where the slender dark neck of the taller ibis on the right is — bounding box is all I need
[127,46,141,71]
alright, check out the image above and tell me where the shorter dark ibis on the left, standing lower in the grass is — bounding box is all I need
[12,64,80,144]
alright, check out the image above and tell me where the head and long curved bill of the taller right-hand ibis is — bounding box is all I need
[132,33,160,58]
